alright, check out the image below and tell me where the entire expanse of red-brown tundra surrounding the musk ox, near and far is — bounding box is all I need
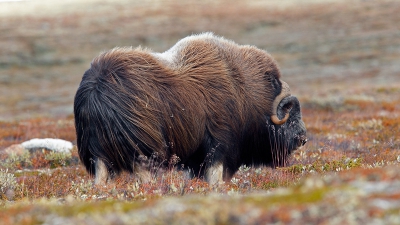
[0,0,400,224]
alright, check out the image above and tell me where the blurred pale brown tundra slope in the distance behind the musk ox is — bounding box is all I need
[0,0,400,120]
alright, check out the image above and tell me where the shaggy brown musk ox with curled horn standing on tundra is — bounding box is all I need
[74,33,307,184]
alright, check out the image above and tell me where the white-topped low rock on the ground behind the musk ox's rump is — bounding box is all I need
[21,138,73,152]
